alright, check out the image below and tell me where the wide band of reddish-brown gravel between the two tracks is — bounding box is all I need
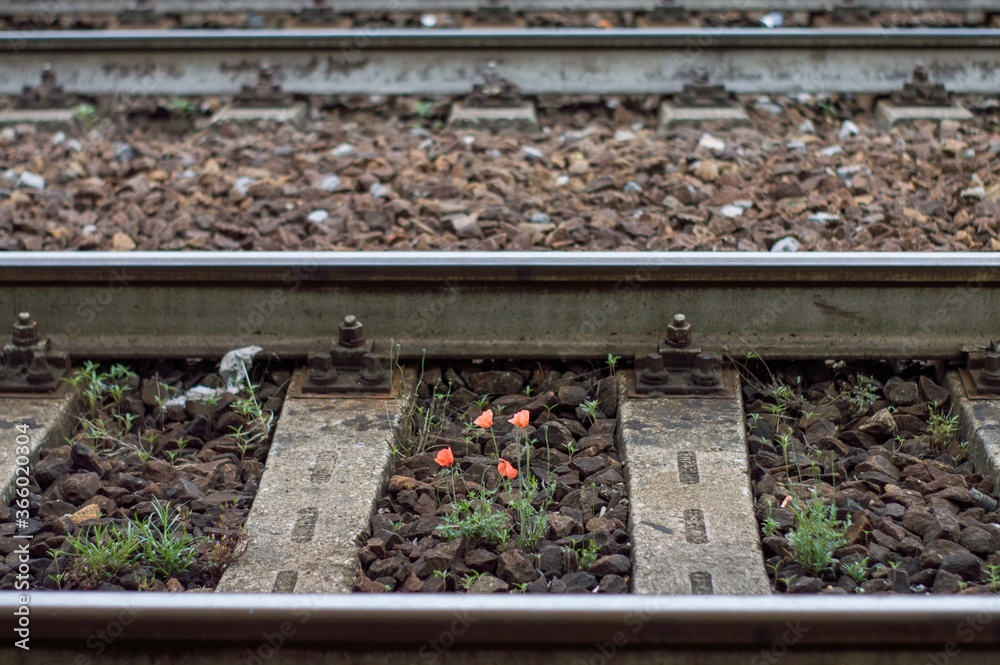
[0,95,1000,251]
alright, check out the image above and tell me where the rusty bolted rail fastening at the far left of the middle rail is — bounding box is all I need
[0,312,70,393]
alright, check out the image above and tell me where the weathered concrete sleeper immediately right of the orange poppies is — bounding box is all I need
[618,376,771,594]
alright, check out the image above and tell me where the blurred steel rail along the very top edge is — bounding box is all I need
[0,0,1000,16]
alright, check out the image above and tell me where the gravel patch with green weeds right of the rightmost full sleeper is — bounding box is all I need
[744,363,1000,594]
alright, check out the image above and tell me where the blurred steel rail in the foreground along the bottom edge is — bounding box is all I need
[0,591,1000,651]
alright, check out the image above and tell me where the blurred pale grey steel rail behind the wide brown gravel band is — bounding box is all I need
[0,27,1000,97]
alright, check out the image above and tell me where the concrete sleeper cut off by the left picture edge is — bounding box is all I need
[0,390,77,503]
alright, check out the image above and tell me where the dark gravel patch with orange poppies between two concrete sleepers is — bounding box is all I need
[355,364,632,593]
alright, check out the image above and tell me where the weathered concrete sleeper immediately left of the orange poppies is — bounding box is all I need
[216,374,396,593]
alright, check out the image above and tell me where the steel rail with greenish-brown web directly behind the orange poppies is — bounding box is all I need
[0,252,1000,359]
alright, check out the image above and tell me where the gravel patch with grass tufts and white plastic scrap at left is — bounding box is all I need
[0,361,290,591]
